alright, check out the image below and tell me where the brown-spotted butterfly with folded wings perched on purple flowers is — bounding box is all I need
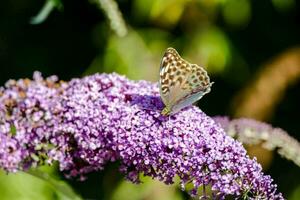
[159,47,213,116]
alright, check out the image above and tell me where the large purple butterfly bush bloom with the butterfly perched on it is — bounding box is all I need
[0,73,283,199]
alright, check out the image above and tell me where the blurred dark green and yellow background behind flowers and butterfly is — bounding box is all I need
[0,0,300,200]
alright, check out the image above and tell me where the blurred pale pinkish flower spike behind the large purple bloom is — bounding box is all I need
[214,116,300,166]
